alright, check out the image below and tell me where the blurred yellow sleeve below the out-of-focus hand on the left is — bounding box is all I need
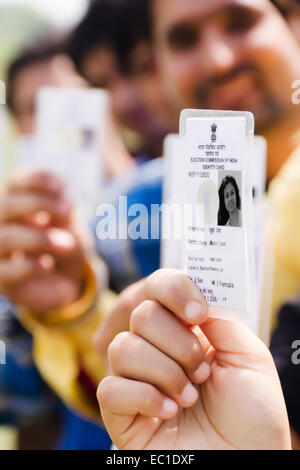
[20,266,116,421]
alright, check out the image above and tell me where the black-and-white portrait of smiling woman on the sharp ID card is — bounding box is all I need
[218,172,242,227]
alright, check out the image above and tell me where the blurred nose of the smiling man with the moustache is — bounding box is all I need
[199,26,238,77]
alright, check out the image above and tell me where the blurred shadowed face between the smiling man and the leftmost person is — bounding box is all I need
[82,45,172,138]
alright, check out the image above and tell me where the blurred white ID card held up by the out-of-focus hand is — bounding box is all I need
[36,88,109,220]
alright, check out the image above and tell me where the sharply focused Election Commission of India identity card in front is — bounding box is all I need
[180,110,256,323]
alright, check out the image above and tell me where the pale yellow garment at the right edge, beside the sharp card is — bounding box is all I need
[269,147,300,326]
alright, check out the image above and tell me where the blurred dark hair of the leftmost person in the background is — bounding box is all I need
[6,36,66,113]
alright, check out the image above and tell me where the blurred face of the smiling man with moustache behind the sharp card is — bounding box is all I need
[153,0,300,129]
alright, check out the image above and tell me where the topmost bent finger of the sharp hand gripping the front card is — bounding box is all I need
[144,269,208,325]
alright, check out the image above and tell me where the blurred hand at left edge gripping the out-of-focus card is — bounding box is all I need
[0,172,91,311]
